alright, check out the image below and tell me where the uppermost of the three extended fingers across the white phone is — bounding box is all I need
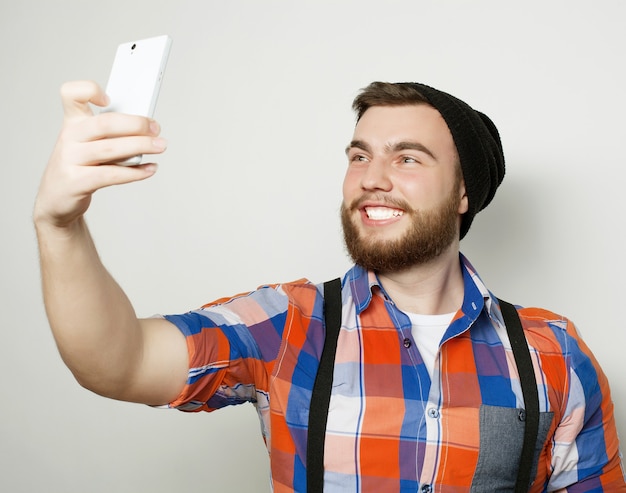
[65,113,161,142]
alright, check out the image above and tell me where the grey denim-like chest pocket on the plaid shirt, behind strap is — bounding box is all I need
[470,405,554,493]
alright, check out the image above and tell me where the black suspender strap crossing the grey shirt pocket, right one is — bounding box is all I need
[498,299,539,493]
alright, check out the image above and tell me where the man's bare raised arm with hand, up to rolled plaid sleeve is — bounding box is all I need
[34,81,188,404]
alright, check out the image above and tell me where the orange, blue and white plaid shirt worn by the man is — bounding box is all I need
[166,256,626,493]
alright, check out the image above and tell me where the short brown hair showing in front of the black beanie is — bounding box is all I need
[352,82,432,121]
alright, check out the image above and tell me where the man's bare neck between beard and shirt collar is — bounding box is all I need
[378,243,464,315]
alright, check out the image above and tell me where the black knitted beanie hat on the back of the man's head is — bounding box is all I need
[406,82,504,239]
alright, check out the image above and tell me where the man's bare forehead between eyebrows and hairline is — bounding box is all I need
[354,104,456,154]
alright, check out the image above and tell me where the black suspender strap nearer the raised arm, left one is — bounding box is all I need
[306,278,341,493]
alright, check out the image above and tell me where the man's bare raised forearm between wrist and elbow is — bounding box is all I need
[35,218,141,396]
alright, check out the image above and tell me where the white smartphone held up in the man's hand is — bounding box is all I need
[102,35,172,166]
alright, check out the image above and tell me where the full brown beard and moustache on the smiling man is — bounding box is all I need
[341,187,461,273]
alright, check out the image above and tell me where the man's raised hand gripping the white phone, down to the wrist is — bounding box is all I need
[34,81,166,227]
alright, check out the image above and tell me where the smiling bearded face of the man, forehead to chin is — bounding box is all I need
[341,104,467,272]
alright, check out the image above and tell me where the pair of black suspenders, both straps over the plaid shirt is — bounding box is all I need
[306,279,539,493]
